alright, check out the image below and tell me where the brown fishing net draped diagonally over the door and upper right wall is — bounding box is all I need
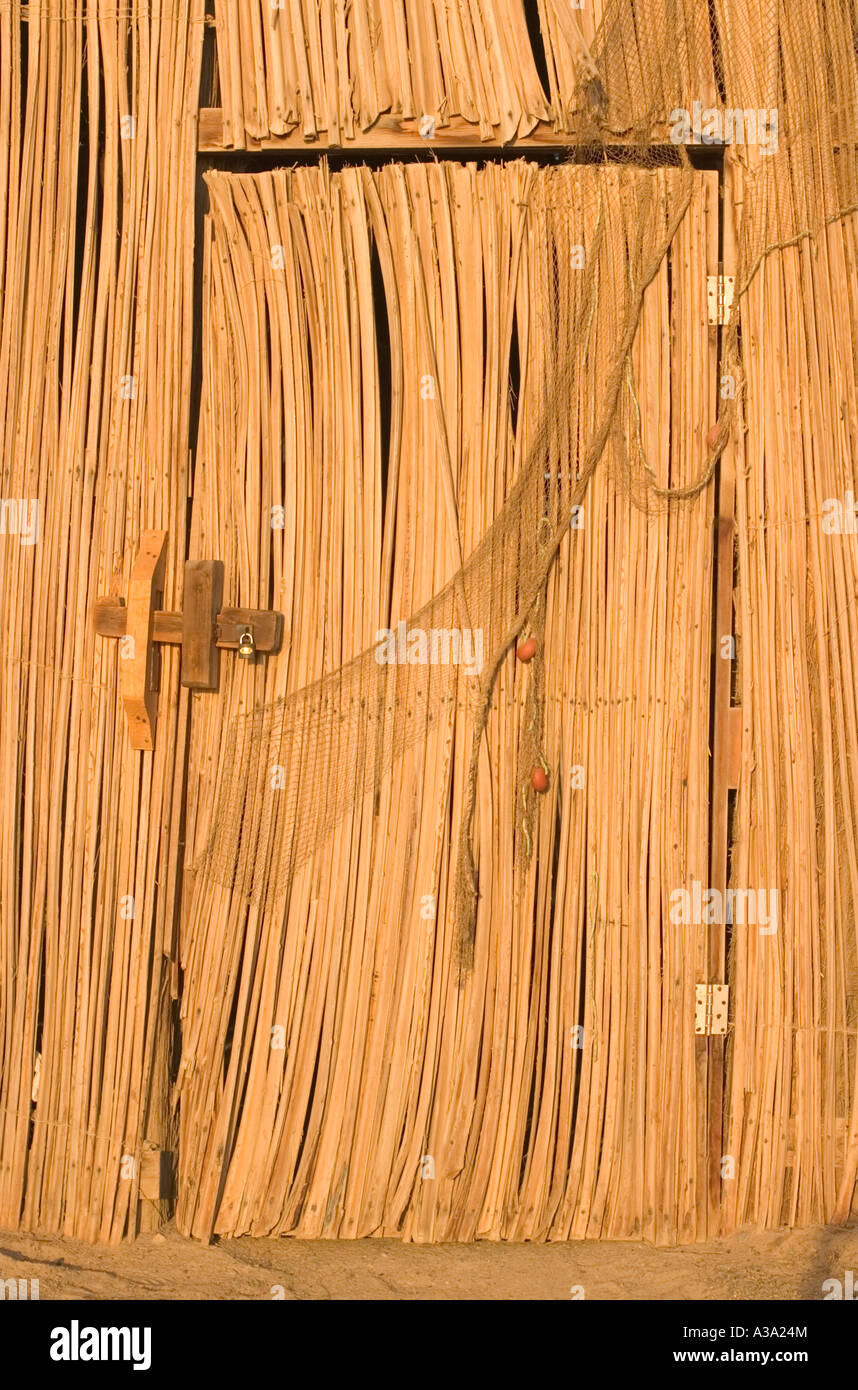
[196,0,858,969]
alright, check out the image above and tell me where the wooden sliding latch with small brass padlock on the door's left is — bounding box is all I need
[93,531,282,751]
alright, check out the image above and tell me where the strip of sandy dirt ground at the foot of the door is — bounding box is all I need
[0,1226,858,1301]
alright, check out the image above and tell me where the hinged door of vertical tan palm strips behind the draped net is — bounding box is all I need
[177,163,722,1241]
